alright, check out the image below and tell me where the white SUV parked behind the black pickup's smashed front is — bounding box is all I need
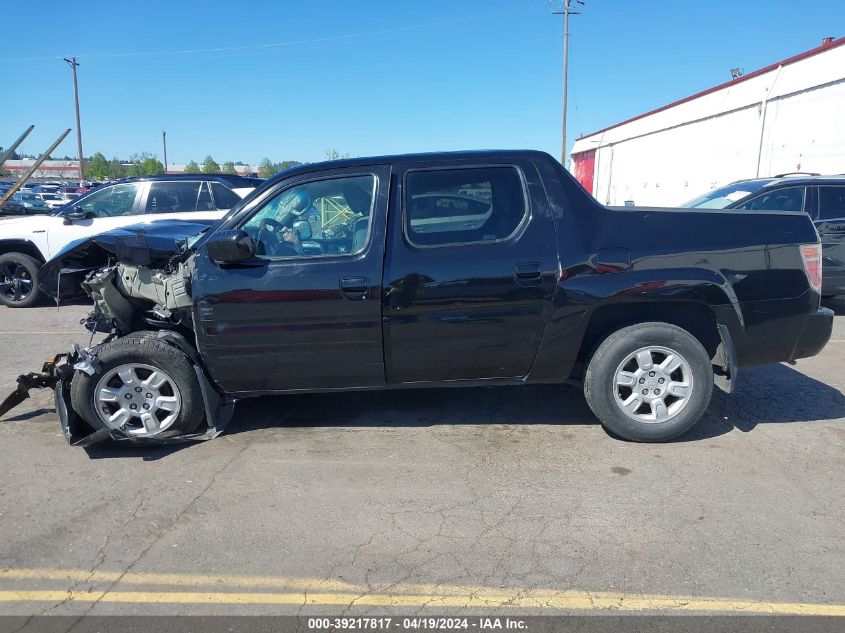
[0,174,261,308]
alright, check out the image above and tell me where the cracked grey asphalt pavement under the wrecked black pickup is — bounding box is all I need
[0,302,845,615]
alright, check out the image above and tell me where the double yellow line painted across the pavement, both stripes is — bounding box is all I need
[0,569,845,617]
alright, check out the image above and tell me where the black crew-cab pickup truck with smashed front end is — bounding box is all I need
[0,151,833,444]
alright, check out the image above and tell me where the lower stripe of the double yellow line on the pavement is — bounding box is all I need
[0,590,845,617]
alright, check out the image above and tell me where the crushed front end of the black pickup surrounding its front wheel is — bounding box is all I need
[0,227,235,446]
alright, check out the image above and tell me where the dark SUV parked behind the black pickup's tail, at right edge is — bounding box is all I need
[681,174,845,296]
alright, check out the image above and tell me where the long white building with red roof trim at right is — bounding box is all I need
[572,38,845,206]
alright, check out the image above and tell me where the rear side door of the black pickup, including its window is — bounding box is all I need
[384,161,558,384]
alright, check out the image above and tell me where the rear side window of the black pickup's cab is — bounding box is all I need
[403,166,528,246]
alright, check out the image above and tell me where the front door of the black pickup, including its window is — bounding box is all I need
[192,166,390,393]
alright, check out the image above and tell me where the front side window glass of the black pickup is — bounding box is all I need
[242,175,376,259]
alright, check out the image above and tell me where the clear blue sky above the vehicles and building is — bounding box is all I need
[0,0,845,163]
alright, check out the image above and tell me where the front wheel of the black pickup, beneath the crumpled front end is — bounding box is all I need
[70,332,205,438]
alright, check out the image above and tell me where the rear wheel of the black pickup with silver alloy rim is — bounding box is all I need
[584,323,713,442]
